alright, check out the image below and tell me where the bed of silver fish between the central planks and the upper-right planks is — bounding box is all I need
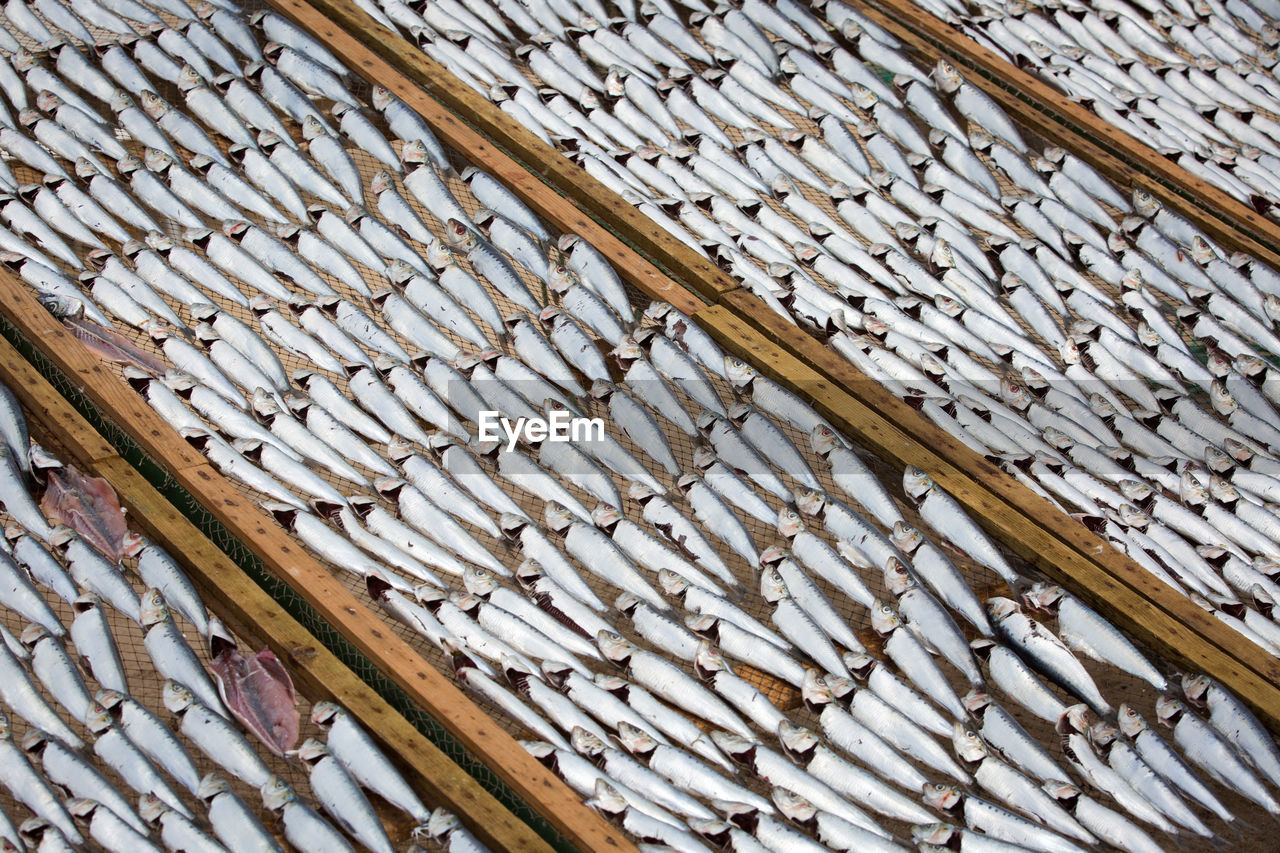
[360,1,1280,653]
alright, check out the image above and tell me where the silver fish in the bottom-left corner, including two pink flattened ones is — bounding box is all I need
[0,387,483,853]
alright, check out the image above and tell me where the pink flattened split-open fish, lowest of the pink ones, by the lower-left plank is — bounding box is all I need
[209,625,301,756]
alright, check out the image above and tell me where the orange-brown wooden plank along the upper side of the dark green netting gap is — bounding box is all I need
[0,272,636,853]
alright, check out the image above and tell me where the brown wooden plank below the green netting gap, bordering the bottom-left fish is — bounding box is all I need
[0,330,550,852]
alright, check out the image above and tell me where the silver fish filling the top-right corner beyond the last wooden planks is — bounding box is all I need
[942,1,1280,218]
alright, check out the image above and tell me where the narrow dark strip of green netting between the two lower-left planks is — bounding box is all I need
[0,308,575,853]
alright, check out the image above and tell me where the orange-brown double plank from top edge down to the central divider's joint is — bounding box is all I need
[268,0,721,314]
